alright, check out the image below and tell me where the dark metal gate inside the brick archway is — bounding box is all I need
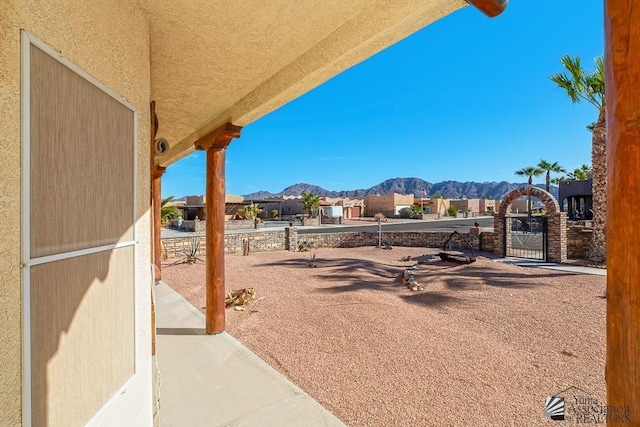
[504,215,547,261]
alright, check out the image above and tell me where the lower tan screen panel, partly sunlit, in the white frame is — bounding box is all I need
[31,246,135,427]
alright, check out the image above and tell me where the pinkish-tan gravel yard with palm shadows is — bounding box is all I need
[163,247,606,426]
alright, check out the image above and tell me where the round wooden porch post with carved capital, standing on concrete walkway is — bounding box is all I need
[195,123,242,334]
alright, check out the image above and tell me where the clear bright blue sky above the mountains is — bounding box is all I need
[162,0,604,197]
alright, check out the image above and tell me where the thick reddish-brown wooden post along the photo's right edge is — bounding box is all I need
[604,0,640,426]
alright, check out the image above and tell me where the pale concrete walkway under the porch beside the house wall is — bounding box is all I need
[155,282,344,427]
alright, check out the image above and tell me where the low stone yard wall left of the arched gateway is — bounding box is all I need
[162,227,487,256]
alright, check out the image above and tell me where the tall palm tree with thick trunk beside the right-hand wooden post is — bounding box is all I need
[551,55,607,262]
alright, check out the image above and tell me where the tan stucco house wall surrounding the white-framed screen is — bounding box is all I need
[0,0,151,426]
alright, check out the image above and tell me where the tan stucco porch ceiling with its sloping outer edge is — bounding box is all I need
[148,0,467,166]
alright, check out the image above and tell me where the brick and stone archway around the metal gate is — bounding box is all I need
[493,187,567,263]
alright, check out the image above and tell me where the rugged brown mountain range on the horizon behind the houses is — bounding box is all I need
[244,178,558,200]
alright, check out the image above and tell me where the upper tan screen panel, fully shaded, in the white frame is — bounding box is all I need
[30,46,135,259]
